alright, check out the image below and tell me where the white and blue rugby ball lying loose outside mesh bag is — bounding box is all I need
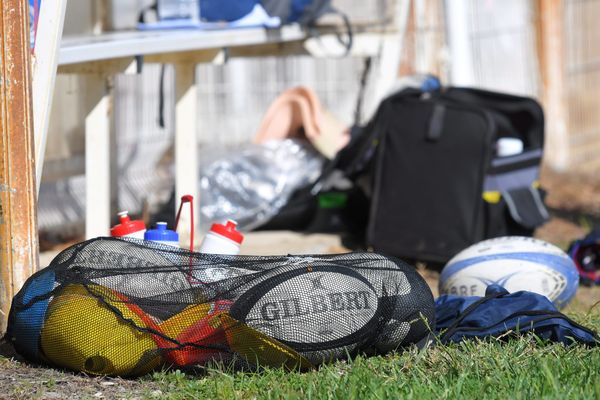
[439,236,579,308]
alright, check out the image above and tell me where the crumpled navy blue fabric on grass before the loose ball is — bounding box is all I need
[435,285,600,346]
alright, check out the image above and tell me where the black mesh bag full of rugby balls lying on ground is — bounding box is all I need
[7,238,434,376]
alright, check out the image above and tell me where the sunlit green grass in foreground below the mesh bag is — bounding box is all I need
[148,312,600,399]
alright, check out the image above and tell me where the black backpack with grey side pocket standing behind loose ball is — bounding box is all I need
[342,87,548,262]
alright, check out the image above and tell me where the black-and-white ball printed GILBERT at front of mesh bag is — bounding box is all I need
[230,265,380,363]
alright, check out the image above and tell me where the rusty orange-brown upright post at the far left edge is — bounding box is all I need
[0,0,38,332]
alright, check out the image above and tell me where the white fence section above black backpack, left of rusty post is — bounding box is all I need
[446,0,540,97]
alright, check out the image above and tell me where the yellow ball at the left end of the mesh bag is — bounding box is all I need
[41,285,160,375]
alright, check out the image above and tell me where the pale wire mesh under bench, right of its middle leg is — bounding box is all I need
[197,56,363,148]
